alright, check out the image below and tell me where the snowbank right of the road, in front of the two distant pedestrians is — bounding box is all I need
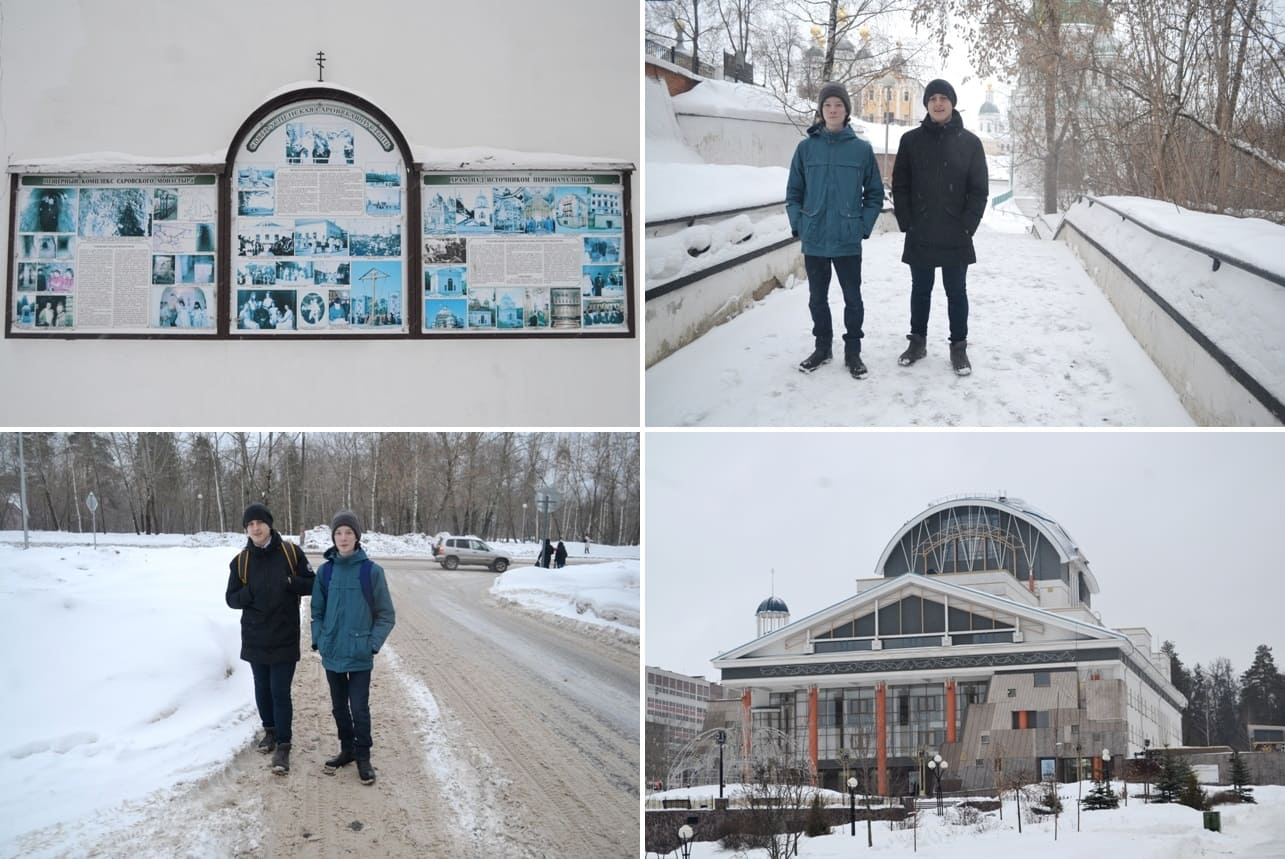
[491,561,641,639]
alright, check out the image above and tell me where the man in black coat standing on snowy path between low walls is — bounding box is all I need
[892,78,989,375]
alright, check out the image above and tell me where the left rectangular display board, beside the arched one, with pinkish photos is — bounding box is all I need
[9,172,218,336]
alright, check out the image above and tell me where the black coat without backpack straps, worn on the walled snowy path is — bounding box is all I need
[892,111,989,267]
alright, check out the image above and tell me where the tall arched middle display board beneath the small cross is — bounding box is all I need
[229,99,409,336]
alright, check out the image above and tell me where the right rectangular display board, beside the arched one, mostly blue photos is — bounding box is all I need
[421,171,628,336]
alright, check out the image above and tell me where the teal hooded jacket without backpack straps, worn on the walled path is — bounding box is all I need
[785,123,884,257]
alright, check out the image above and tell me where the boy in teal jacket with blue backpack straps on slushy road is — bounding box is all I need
[312,511,397,784]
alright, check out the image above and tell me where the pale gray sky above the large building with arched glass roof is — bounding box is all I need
[644,430,1285,680]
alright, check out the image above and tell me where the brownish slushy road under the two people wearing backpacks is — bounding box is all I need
[81,559,640,856]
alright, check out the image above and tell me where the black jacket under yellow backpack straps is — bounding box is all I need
[227,529,316,665]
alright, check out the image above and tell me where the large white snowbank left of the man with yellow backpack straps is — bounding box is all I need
[0,547,257,855]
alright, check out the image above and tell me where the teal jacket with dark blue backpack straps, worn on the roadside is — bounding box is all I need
[312,545,397,674]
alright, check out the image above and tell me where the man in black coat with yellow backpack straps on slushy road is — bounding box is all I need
[226,503,315,775]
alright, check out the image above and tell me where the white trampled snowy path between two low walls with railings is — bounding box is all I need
[646,219,1192,427]
